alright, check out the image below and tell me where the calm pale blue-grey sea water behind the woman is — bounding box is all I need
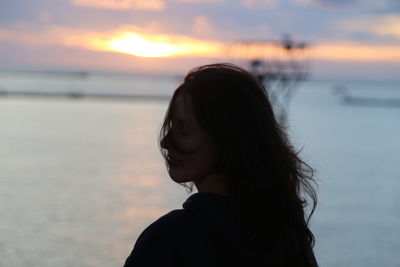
[0,73,400,267]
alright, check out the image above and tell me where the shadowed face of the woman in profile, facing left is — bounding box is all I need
[161,93,218,191]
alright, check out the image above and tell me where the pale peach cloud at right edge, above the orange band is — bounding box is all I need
[338,14,400,40]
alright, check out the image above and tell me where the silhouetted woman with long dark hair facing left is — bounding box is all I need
[125,64,317,267]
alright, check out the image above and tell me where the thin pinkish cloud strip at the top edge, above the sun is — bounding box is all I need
[70,0,165,11]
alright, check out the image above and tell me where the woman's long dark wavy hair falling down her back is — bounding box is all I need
[160,63,317,266]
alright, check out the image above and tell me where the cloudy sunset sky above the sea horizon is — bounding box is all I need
[0,0,400,80]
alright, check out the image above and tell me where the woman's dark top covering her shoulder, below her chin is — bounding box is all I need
[124,193,318,267]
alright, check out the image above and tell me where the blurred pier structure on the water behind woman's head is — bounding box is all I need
[227,35,310,124]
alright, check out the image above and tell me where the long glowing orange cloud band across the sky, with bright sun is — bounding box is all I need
[0,25,400,62]
